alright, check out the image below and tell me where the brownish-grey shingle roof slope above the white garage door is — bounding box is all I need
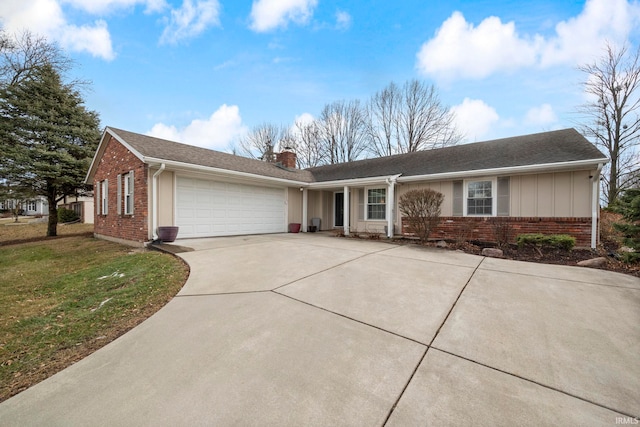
[109,127,313,182]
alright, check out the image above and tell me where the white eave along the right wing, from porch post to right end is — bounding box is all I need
[398,157,609,182]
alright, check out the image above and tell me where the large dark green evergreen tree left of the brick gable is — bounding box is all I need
[0,64,100,236]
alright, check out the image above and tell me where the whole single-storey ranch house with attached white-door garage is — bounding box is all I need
[86,128,608,247]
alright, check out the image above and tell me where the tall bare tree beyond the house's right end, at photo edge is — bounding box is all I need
[579,44,640,205]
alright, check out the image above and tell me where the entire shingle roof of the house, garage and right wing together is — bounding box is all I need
[109,127,606,186]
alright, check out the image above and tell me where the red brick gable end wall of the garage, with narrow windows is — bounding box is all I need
[93,138,149,243]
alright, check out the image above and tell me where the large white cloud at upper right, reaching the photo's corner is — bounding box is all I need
[417,0,640,80]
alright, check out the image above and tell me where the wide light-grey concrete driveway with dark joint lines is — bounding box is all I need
[0,234,640,426]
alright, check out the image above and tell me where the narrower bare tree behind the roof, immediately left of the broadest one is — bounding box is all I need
[319,99,366,164]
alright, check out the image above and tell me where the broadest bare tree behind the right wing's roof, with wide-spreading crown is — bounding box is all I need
[367,79,462,156]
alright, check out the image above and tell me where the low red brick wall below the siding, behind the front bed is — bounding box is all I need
[402,216,591,247]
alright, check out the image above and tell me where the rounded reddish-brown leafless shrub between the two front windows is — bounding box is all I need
[399,188,444,242]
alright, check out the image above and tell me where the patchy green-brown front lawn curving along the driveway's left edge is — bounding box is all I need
[0,237,188,401]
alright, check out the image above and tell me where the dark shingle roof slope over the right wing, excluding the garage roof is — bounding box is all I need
[308,129,606,182]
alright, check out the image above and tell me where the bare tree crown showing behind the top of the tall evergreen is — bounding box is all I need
[0,30,73,86]
